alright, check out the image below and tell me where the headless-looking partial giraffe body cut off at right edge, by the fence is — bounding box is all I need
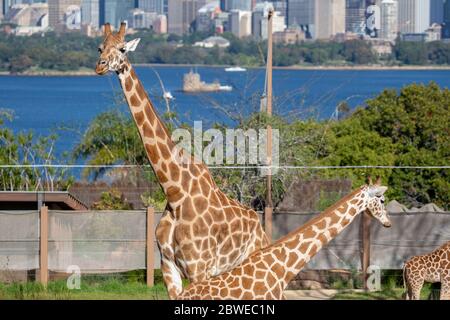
[403,241,450,300]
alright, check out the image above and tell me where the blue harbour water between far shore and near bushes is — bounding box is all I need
[0,66,450,158]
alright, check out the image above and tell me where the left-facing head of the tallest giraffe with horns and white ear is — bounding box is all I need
[95,23,141,75]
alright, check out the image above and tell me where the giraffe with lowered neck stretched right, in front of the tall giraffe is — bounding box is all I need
[178,180,391,300]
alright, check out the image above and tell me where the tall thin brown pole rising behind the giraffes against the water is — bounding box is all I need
[264,10,273,242]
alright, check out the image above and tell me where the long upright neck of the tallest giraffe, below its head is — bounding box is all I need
[118,61,186,204]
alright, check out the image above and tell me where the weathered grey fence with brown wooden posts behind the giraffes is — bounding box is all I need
[0,206,450,286]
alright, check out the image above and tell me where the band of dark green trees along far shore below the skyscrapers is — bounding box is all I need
[0,30,450,73]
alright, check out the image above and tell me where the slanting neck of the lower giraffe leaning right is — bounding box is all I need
[263,189,368,289]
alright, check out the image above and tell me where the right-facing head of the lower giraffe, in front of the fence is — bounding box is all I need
[365,177,392,228]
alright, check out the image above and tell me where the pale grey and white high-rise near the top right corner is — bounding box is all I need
[398,0,430,33]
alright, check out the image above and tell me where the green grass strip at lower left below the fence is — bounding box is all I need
[0,272,168,300]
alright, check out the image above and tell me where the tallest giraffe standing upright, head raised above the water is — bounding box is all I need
[96,23,269,299]
